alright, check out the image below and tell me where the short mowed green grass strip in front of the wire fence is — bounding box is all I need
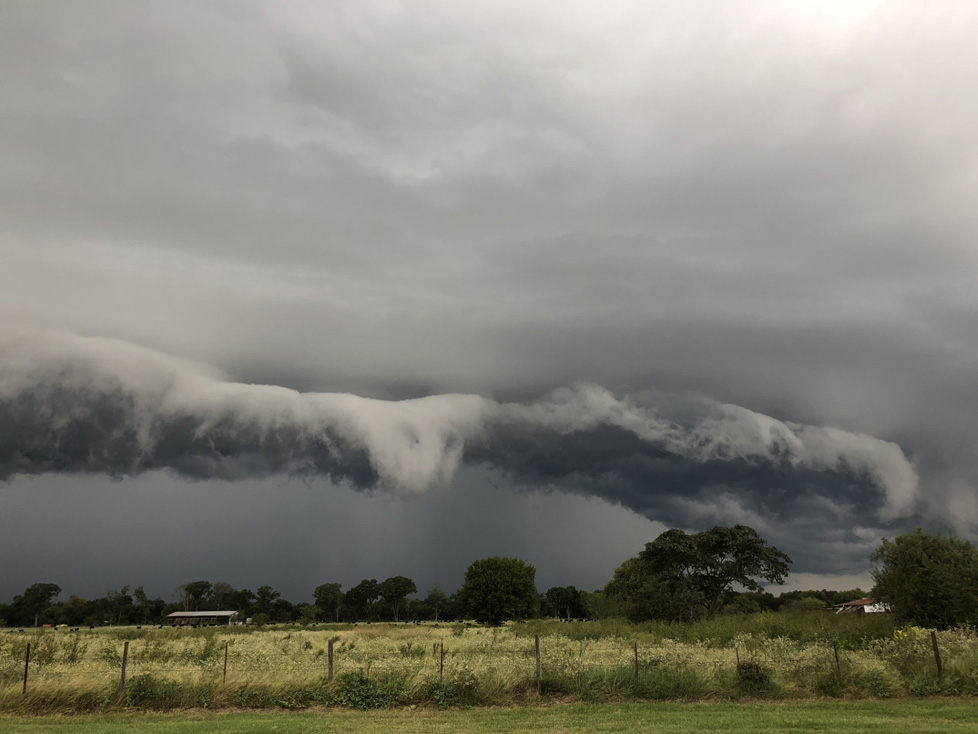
[0,699,978,734]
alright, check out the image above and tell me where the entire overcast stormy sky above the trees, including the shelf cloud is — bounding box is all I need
[0,0,978,601]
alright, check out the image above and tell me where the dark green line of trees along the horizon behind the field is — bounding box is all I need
[0,525,978,628]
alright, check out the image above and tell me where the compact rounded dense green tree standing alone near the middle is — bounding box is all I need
[459,556,540,626]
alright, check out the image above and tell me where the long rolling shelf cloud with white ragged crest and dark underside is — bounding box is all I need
[0,331,917,536]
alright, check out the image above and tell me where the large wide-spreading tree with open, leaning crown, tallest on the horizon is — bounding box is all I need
[608,525,791,620]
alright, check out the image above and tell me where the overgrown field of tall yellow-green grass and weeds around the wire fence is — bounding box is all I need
[0,612,978,712]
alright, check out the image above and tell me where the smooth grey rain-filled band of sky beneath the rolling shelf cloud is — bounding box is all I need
[0,468,665,602]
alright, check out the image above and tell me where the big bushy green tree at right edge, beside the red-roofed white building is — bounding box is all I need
[870,528,978,629]
